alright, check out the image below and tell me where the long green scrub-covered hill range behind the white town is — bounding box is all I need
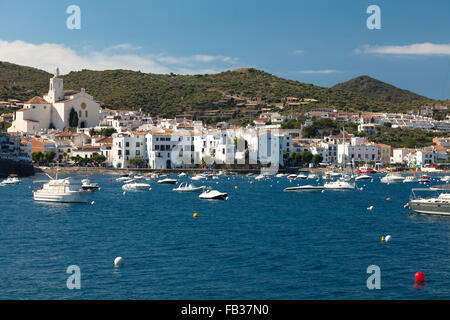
[0,62,438,120]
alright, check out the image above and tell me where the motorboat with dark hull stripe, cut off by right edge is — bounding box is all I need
[405,188,450,216]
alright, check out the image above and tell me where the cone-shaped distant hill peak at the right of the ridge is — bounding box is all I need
[333,76,431,103]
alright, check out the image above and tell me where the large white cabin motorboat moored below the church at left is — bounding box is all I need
[33,177,91,203]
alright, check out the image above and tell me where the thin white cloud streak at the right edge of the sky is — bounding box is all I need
[355,42,450,55]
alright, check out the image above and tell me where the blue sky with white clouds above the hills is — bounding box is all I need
[0,0,450,99]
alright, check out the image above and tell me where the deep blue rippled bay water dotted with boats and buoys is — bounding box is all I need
[0,175,450,299]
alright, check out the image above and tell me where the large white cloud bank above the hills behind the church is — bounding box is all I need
[0,40,237,74]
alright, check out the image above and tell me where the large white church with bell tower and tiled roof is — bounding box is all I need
[8,68,100,134]
